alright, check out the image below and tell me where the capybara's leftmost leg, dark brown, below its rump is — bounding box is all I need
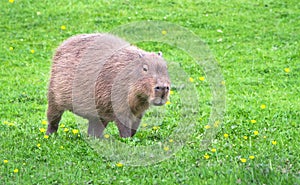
[46,105,64,135]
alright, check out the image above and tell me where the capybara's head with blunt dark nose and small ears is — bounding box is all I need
[131,52,171,106]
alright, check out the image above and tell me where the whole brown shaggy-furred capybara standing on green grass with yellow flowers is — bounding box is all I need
[47,34,170,137]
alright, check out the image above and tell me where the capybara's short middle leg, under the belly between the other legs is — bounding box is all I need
[88,118,108,138]
